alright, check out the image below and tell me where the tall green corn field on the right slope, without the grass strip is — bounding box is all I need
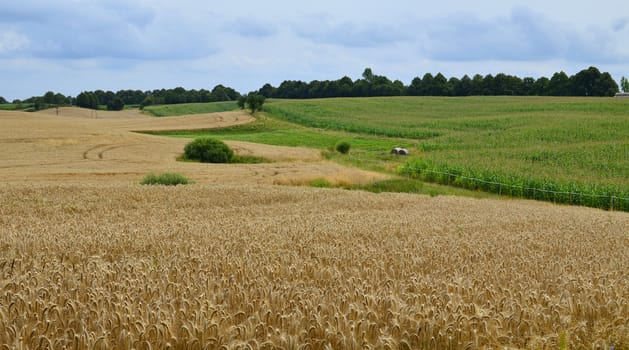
[266,97,629,207]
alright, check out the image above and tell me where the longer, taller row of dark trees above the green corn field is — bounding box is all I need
[257,67,618,99]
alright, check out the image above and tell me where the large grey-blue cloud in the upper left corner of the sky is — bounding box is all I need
[0,0,216,60]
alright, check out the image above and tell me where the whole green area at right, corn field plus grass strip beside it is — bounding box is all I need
[145,97,629,210]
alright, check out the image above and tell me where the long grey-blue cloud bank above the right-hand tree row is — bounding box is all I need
[290,7,629,62]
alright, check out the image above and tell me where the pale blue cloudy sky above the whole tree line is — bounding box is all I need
[0,0,629,100]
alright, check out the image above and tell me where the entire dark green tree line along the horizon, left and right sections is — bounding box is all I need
[0,67,629,110]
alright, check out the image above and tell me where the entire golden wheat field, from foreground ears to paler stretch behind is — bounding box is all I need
[0,108,629,349]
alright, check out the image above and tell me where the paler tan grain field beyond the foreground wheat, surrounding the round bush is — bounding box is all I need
[0,108,384,184]
